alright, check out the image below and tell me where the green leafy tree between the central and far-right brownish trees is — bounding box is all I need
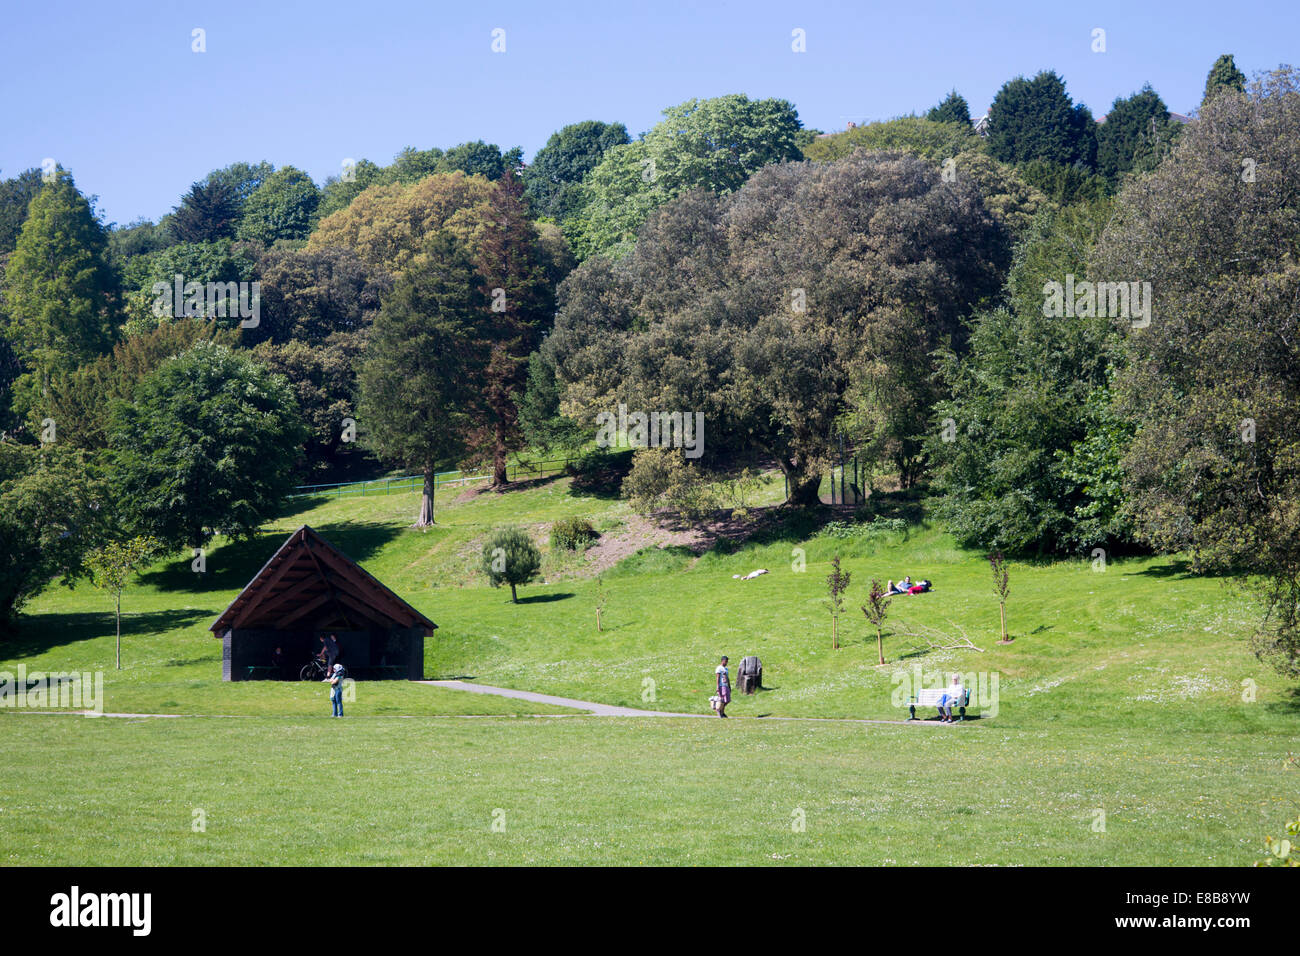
[928,202,1128,553]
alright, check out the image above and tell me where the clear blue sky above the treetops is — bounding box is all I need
[0,0,1300,224]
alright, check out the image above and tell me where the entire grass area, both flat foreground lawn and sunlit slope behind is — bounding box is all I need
[0,479,1300,865]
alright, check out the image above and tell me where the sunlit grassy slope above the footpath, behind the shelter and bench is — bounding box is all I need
[0,479,1300,732]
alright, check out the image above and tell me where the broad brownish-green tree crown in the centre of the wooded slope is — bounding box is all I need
[546,153,1005,502]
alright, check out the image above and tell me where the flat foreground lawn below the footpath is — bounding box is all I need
[0,715,1295,865]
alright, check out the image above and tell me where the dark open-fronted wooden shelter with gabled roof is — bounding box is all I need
[208,524,437,680]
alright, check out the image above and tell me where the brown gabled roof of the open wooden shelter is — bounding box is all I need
[208,524,437,636]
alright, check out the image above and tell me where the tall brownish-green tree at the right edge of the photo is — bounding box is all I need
[1096,69,1300,675]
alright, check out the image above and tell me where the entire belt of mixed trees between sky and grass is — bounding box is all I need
[0,56,1300,674]
